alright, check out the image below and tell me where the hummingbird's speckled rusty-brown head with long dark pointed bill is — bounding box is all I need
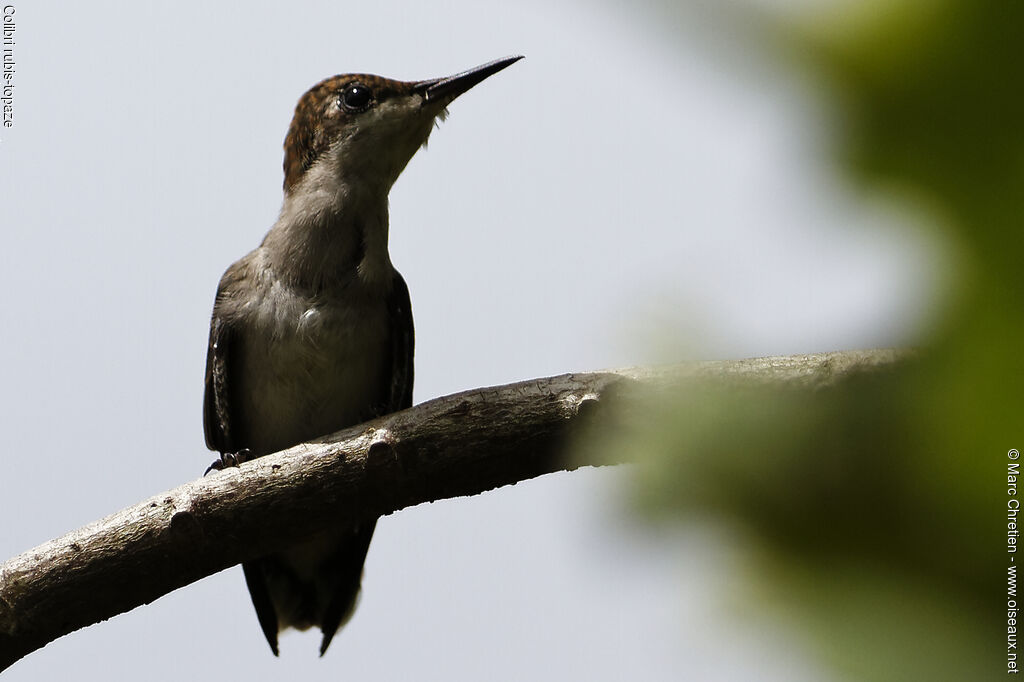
[285,56,522,195]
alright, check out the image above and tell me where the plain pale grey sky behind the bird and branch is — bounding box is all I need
[0,0,929,682]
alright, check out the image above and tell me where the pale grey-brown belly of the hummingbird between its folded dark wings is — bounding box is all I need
[234,284,391,455]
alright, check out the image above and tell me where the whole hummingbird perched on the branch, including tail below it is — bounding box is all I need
[204,56,522,655]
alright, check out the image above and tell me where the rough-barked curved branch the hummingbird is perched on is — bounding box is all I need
[0,350,902,671]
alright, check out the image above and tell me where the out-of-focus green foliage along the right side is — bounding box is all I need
[602,0,1024,680]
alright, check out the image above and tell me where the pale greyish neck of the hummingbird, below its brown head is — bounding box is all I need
[263,166,392,291]
